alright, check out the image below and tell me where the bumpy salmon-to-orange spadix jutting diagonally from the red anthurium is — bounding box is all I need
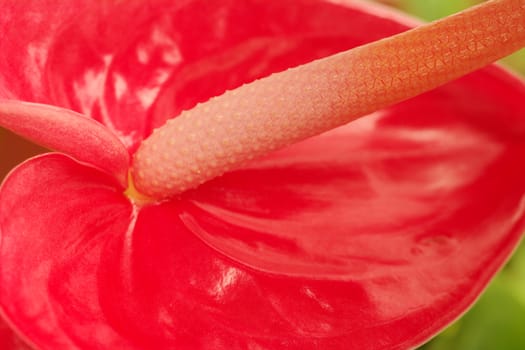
[132,0,525,198]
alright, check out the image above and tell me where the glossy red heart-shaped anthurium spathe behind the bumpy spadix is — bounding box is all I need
[0,1,525,349]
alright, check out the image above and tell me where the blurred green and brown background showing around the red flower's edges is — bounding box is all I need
[0,0,525,350]
